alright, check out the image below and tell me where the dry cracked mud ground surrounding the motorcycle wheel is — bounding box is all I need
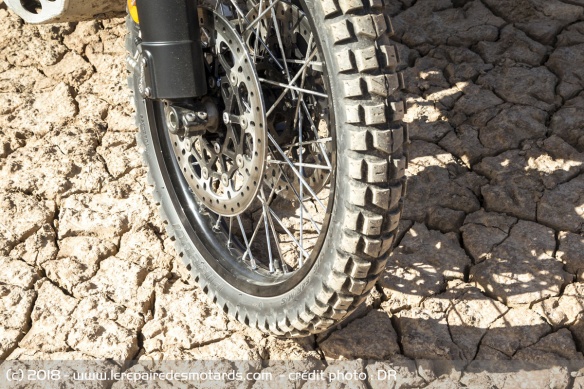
[0,0,584,388]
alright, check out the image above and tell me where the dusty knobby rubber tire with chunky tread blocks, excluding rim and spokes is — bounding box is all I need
[126,0,409,337]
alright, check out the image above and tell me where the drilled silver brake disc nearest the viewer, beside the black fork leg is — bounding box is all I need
[170,9,268,216]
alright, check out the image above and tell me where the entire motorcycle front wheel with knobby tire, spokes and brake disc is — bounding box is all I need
[127,0,408,337]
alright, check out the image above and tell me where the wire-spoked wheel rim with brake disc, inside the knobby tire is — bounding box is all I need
[152,1,336,296]
